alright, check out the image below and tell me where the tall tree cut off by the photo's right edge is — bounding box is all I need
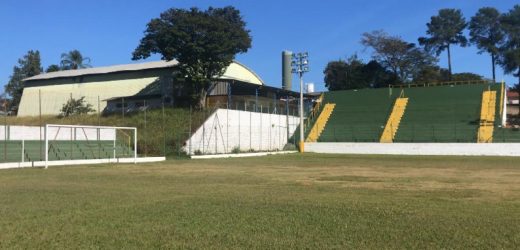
[499,5,520,84]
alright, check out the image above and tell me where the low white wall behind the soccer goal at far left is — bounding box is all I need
[0,126,116,141]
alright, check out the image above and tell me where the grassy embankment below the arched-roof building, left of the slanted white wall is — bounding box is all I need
[1,108,207,156]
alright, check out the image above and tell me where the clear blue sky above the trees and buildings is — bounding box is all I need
[0,0,517,92]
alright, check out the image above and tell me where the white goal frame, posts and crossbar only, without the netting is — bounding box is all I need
[44,124,137,169]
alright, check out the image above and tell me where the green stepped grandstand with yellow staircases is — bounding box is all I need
[307,83,520,142]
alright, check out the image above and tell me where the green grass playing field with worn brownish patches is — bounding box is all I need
[0,154,520,249]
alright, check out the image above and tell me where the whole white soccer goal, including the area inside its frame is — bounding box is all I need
[44,124,137,168]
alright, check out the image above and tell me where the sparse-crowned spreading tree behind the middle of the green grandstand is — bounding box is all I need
[361,30,436,82]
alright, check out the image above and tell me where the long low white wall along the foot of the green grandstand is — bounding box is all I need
[305,142,520,156]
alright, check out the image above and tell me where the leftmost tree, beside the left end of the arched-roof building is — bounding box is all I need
[5,50,43,106]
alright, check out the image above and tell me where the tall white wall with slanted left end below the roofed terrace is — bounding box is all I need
[185,109,299,154]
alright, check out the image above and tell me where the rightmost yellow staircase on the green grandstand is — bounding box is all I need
[478,90,497,143]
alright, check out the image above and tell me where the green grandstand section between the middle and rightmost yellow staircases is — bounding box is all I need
[395,84,500,142]
